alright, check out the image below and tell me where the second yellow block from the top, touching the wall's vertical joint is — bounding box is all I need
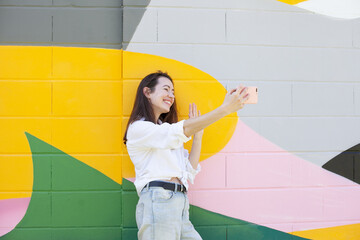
[53,81,122,117]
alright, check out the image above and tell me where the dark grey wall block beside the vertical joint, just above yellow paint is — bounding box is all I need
[53,8,122,44]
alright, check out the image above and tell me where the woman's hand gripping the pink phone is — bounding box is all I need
[221,85,249,114]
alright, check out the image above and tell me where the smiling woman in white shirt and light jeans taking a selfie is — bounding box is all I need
[124,71,248,240]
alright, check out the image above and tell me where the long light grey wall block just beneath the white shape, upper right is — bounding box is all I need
[226,11,352,47]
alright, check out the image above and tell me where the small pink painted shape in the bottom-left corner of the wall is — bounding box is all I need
[0,198,31,236]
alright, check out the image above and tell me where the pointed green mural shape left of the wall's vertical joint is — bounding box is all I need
[0,133,122,240]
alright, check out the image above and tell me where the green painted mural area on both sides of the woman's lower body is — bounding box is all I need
[0,133,305,240]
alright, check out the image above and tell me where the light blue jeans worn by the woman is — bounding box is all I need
[136,187,202,240]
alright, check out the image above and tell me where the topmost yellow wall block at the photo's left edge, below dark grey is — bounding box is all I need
[0,46,52,80]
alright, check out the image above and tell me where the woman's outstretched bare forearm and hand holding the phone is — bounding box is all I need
[183,85,248,137]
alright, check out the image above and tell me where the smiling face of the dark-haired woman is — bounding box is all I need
[148,77,175,119]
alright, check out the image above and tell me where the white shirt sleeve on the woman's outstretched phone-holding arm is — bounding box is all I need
[126,120,191,149]
